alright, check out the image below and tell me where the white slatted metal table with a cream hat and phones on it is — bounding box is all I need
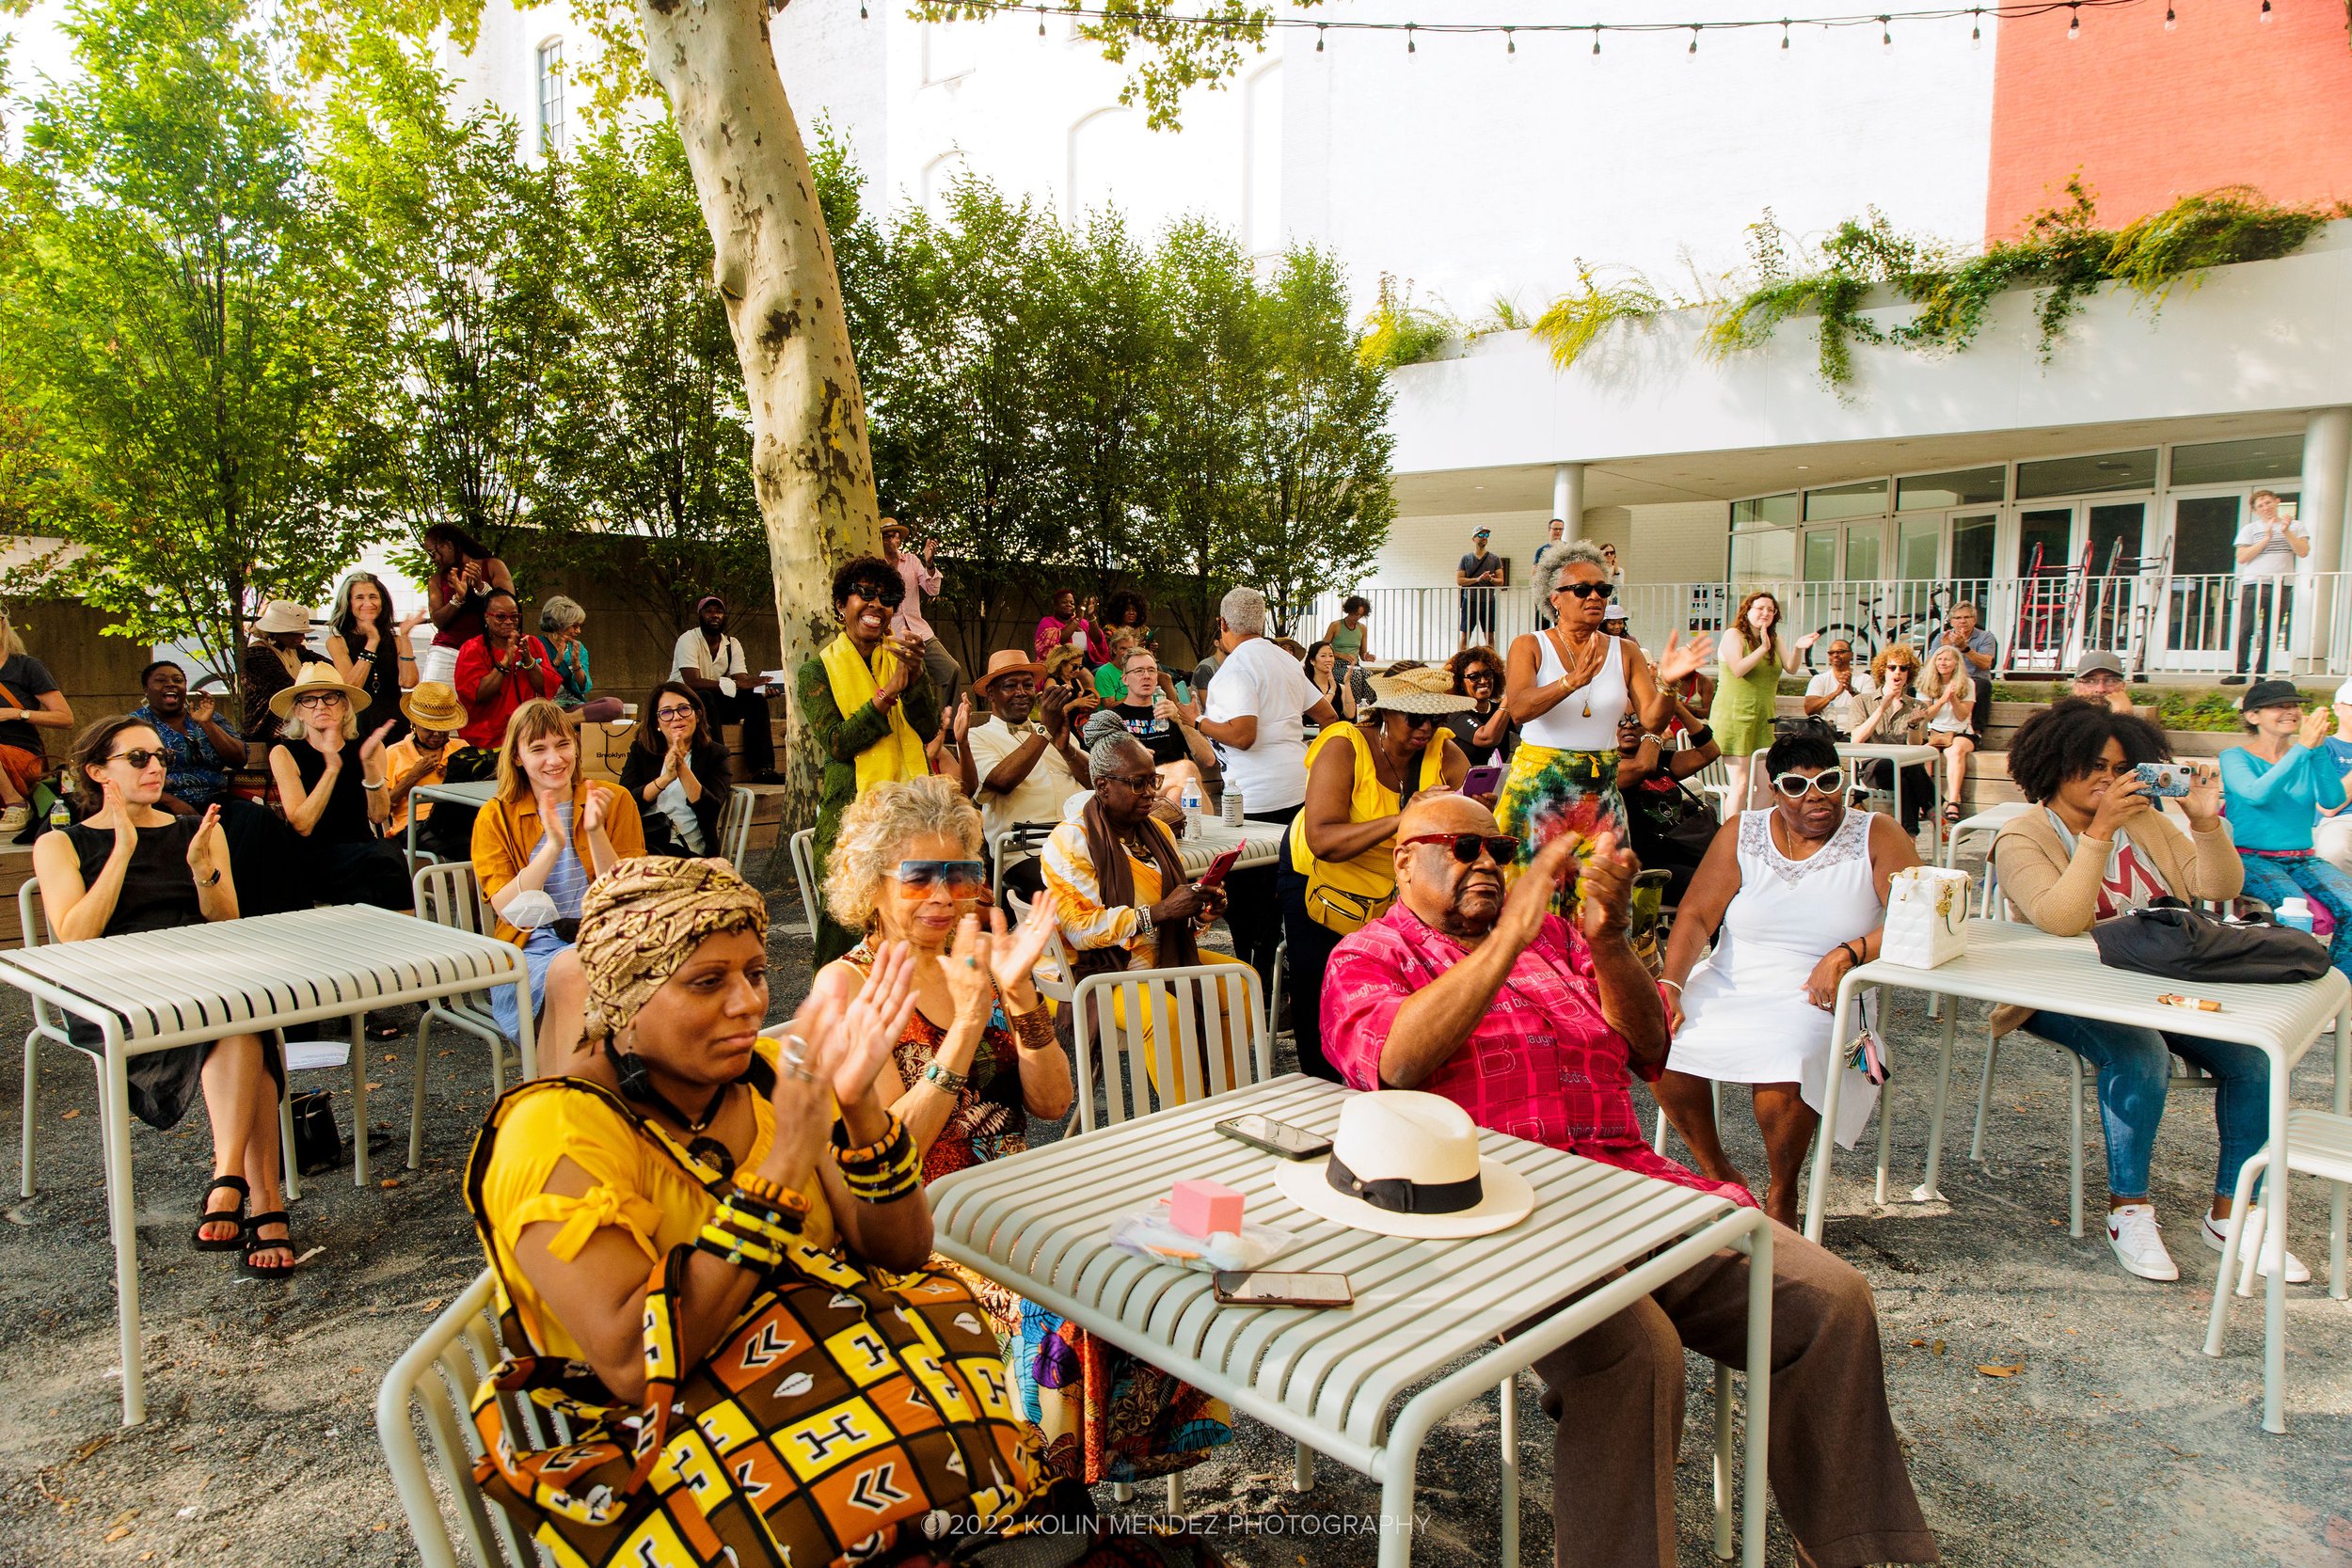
[930,1074,1772,1568]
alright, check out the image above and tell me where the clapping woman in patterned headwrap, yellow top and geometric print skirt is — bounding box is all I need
[466,861,1204,1568]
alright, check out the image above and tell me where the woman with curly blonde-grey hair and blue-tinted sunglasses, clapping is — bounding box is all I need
[809,778,1232,1486]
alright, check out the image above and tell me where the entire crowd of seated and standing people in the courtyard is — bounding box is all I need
[37,519,2352,1563]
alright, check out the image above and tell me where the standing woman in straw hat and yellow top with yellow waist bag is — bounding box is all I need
[1275,668,1472,1082]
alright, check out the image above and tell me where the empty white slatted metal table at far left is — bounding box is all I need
[0,905,534,1425]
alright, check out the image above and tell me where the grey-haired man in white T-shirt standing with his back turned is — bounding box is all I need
[1195,588,1339,1004]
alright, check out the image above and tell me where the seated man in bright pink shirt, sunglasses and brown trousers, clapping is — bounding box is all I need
[1322,792,1936,1568]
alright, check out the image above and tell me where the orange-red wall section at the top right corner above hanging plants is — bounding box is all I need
[1985,0,2352,240]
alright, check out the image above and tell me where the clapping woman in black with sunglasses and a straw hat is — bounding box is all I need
[271,665,417,911]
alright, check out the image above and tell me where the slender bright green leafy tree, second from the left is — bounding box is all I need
[323,33,583,576]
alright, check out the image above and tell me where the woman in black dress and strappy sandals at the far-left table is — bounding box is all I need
[33,717,296,1279]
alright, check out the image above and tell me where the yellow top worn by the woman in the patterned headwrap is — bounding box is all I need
[475,1039,835,1361]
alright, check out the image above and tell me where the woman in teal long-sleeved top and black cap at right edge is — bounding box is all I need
[2220,679,2352,975]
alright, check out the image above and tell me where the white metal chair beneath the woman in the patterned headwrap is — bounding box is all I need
[376,1270,548,1568]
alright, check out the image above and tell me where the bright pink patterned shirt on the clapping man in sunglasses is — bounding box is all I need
[1322,903,1755,1209]
